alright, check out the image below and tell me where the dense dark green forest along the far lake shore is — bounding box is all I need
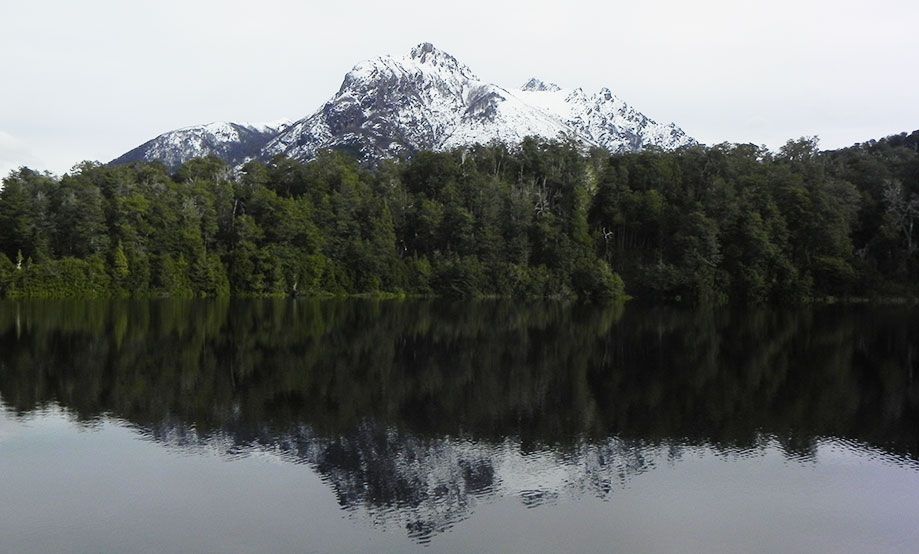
[0,132,919,301]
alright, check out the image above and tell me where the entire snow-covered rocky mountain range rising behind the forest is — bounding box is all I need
[113,43,695,167]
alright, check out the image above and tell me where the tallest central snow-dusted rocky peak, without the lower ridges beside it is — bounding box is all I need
[265,43,573,160]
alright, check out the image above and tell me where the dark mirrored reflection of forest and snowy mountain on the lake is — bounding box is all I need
[0,300,919,541]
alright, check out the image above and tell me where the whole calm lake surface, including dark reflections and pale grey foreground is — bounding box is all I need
[0,301,919,552]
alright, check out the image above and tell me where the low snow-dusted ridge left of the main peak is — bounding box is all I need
[112,120,289,169]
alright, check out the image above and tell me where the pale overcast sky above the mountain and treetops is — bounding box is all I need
[0,0,919,175]
